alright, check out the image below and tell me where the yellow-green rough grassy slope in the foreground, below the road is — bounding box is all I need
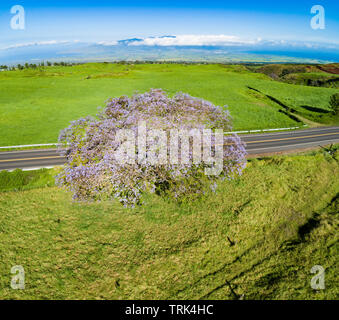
[0,152,339,299]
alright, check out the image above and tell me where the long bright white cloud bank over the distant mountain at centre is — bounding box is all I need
[129,34,261,46]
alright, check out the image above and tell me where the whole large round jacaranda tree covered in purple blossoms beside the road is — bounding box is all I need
[57,89,246,206]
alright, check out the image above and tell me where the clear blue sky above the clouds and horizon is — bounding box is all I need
[0,0,339,46]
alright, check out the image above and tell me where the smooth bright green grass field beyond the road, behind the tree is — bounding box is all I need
[0,63,338,146]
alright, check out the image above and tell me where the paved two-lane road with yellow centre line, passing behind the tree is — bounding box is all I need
[0,127,339,170]
